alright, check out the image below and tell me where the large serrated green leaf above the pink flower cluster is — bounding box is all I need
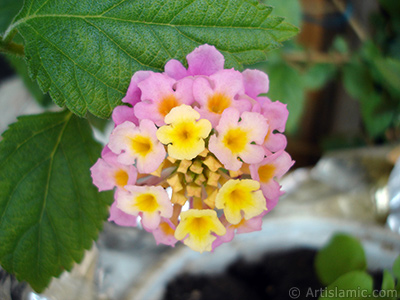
[6,0,298,118]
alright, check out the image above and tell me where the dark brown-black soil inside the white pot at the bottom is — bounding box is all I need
[164,249,323,300]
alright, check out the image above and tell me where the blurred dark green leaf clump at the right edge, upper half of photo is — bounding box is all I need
[343,43,400,138]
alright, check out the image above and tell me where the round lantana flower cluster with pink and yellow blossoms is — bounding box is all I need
[91,45,293,252]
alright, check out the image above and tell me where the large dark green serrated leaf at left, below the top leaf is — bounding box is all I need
[0,112,112,292]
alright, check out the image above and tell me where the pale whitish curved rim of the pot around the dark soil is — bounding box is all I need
[124,217,400,300]
